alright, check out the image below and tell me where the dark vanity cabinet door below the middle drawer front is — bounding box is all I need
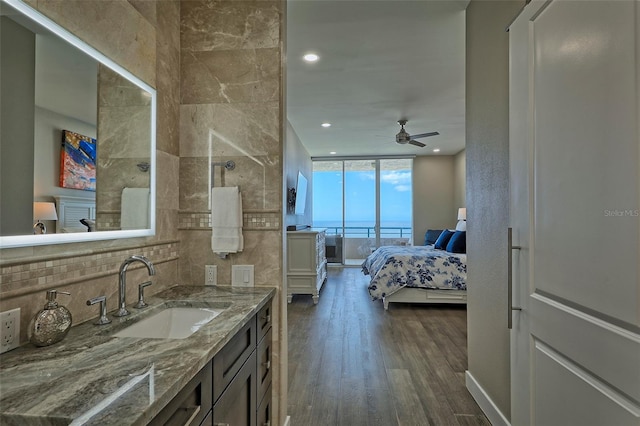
[213,351,257,426]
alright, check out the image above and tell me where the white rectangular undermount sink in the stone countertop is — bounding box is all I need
[114,307,223,339]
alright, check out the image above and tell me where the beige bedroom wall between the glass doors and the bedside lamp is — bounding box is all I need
[413,155,459,245]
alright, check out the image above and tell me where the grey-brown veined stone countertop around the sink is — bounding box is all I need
[0,286,275,426]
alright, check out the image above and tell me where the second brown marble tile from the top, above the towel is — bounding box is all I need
[180,48,280,104]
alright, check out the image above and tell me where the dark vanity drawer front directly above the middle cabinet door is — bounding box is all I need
[213,318,256,402]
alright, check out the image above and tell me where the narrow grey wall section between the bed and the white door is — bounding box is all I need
[466,0,524,424]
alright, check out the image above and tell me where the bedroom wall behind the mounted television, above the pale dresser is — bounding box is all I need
[284,120,313,229]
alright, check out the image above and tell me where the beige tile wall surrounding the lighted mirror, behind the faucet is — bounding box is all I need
[0,0,180,342]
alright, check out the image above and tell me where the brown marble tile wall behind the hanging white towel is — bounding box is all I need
[179,0,287,424]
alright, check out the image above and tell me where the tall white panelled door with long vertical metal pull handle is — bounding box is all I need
[509,0,640,426]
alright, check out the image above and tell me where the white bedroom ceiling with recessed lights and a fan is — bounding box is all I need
[286,0,469,157]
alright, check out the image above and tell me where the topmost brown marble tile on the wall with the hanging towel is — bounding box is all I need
[181,0,281,52]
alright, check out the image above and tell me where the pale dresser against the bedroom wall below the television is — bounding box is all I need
[287,229,327,304]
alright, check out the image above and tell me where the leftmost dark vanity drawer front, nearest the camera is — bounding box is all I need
[149,362,212,426]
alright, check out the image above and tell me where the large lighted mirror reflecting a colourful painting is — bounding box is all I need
[0,0,156,248]
